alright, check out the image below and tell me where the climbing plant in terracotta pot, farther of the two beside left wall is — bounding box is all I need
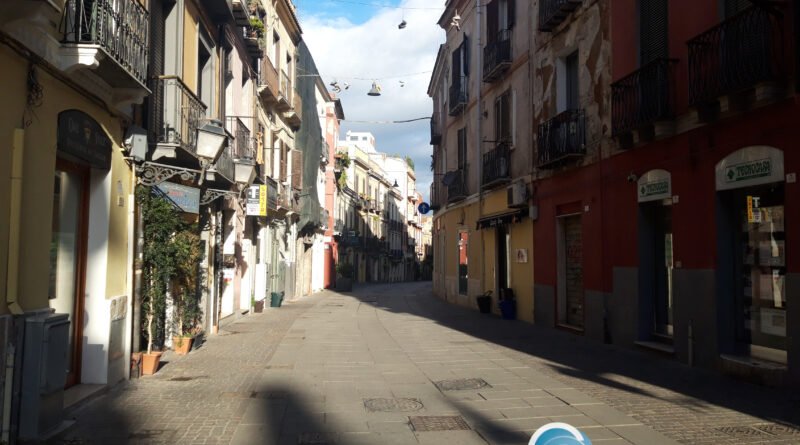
[172,224,203,355]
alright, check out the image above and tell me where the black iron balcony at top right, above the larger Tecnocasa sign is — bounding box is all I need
[687,6,785,106]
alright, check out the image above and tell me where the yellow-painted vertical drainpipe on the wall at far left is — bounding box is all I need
[6,128,25,315]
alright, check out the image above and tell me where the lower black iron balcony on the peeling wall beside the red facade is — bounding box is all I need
[538,109,586,169]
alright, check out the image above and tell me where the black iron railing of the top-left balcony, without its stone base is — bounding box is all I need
[63,0,150,84]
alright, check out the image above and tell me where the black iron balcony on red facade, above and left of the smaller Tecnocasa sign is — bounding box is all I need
[611,59,678,135]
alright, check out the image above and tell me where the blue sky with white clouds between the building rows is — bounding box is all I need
[294,0,445,203]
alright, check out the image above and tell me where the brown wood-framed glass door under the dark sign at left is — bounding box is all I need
[48,159,89,387]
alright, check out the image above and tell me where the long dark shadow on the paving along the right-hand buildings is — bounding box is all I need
[349,282,800,428]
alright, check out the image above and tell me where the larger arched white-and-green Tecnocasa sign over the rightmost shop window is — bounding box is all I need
[715,145,784,190]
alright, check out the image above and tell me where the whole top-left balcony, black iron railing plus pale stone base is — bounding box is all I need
[61,0,150,90]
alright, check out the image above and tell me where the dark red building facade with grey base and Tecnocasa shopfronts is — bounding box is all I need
[532,0,800,385]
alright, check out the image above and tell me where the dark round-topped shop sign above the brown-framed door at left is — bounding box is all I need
[58,110,111,170]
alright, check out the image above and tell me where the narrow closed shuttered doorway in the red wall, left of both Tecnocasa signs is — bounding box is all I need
[556,214,584,329]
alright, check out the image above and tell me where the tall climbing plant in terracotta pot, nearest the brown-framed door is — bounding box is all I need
[136,187,180,375]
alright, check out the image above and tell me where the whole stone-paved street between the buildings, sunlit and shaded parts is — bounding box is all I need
[52,282,800,445]
